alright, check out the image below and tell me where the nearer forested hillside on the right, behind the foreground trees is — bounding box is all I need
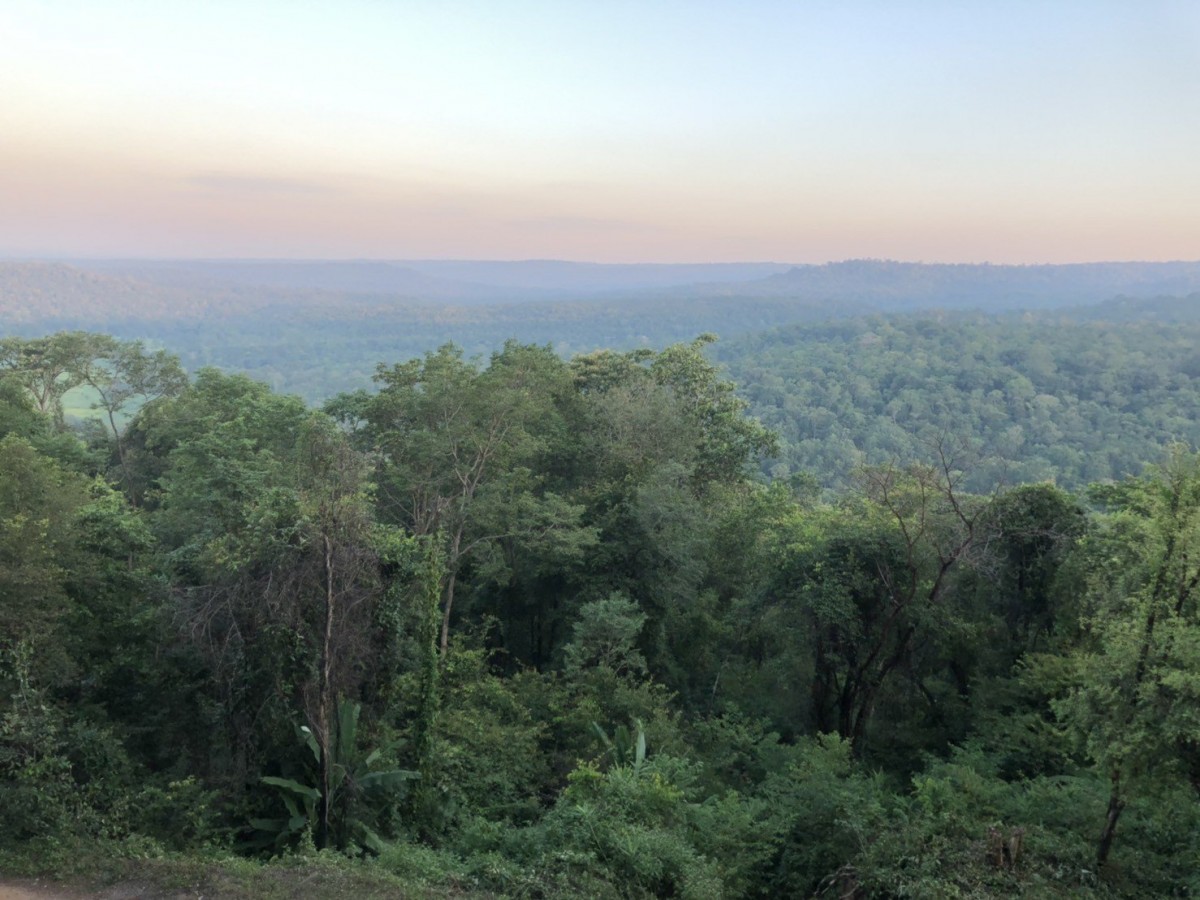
[714,312,1200,491]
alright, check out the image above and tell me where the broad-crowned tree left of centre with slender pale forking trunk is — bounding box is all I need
[330,342,589,655]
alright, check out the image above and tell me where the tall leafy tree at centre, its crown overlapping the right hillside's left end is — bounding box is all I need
[571,335,774,681]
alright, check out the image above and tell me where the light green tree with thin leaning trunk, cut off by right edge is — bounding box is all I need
[1056,448,1200,864]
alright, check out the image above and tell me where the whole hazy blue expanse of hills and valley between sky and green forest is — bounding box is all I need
[7,260,1200,401]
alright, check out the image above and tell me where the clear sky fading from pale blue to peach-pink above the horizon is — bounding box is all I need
[0,0,1200,263]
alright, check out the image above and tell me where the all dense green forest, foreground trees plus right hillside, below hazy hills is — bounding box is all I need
[0,333,1200,898]
